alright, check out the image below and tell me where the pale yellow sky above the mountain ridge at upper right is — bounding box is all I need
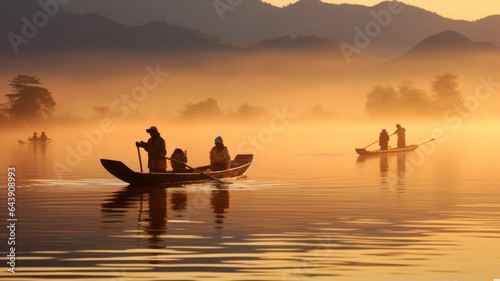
[264,0,500,20]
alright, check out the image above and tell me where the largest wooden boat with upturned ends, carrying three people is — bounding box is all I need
[101,154,253,186]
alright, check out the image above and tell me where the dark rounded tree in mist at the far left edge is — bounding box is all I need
[3,75,56,121]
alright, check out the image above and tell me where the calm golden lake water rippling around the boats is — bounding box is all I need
[0,122,500,281]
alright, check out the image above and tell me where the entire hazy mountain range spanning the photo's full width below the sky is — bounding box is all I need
[0,0,500,59]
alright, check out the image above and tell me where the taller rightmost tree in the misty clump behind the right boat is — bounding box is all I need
[432,72,463,108]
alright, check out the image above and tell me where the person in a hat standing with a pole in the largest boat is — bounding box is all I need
[135,126,167,173]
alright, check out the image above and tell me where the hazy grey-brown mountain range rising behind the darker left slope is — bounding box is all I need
[62,0,500,59]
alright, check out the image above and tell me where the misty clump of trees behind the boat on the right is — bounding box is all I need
[366,72,463,117]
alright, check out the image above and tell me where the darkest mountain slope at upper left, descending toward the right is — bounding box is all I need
[0,1,237,54]
